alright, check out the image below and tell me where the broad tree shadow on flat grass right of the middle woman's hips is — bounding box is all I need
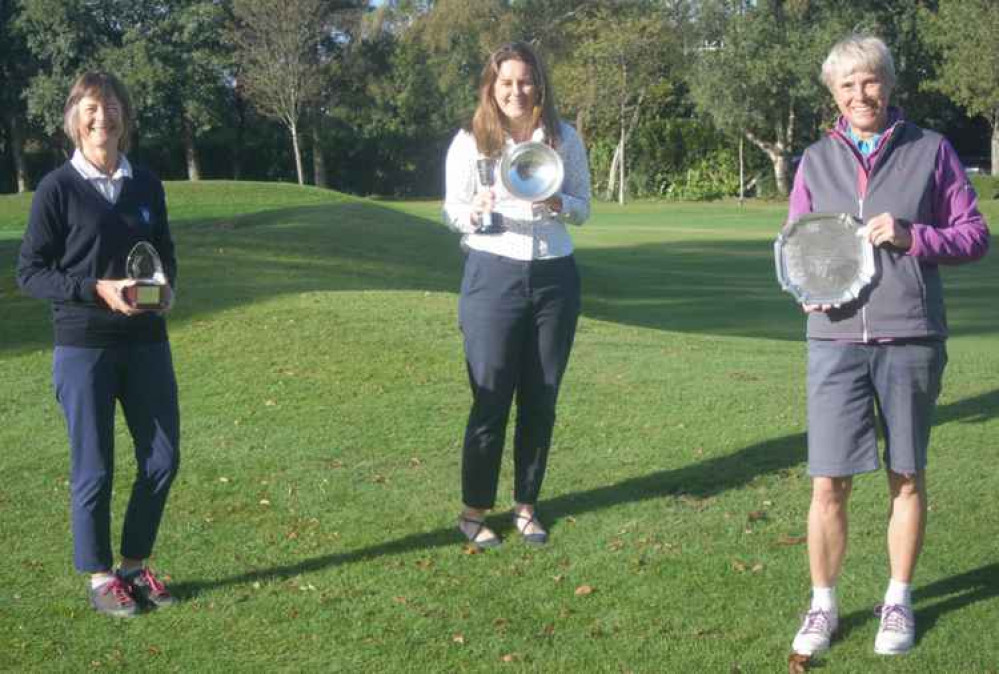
[578,239,999,341]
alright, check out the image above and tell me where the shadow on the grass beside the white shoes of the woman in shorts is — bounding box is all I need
[837,562,999,643]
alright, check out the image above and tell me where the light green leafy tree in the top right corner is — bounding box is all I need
[923,0,999,175]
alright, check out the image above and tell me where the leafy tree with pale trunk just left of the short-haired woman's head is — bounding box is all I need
[690,0,856,196]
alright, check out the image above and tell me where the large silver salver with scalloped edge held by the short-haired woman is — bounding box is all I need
[774,213,877,306]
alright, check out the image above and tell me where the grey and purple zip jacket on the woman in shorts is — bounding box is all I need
[788,108,989,342]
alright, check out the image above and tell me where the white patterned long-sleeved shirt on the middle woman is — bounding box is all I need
[444,122,590,260]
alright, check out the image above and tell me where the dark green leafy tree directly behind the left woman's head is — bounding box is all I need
[12,0,232,180]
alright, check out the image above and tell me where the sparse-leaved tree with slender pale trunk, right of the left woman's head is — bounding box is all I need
[231,0,326,185]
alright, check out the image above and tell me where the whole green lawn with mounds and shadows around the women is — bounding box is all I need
[0,183,999,672]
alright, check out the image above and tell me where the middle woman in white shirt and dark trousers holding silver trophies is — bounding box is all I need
[444,43,590,548]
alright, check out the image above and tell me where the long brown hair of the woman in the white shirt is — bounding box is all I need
[471,42,560,157]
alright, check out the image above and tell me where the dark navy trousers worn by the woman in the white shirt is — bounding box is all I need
[458,250,580,509]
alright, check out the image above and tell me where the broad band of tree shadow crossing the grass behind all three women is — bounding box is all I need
[0,194,999,350]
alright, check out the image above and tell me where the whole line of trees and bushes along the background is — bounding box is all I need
[0,0,999,201]
